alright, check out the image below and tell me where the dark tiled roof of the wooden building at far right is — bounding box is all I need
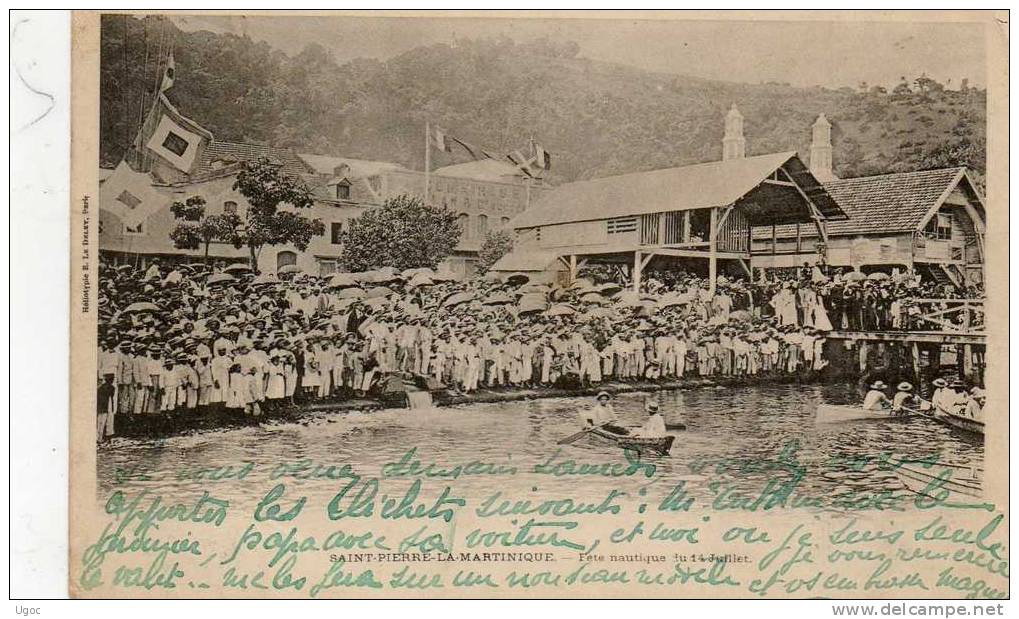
[754,167,965,239]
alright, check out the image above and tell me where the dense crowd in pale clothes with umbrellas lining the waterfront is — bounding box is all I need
[98,260,978,436]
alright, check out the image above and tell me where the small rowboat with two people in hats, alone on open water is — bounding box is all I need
[558,392,676,456]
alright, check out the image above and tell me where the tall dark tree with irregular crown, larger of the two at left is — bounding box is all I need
[224,157,325,272]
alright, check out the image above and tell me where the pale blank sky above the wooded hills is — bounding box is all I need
[173,13,986,89]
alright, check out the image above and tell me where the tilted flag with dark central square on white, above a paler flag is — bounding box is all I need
[136,93,212,173]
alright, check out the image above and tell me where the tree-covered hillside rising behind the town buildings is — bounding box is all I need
[101,15,986,182]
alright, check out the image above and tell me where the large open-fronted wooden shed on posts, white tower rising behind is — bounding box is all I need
[511,146,845,288]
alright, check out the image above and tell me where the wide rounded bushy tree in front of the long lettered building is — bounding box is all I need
[342,195,461,271]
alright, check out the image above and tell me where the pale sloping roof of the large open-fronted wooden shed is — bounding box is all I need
[511,152,842,228]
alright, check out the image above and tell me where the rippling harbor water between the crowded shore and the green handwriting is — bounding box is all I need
[98,384,983,513]
